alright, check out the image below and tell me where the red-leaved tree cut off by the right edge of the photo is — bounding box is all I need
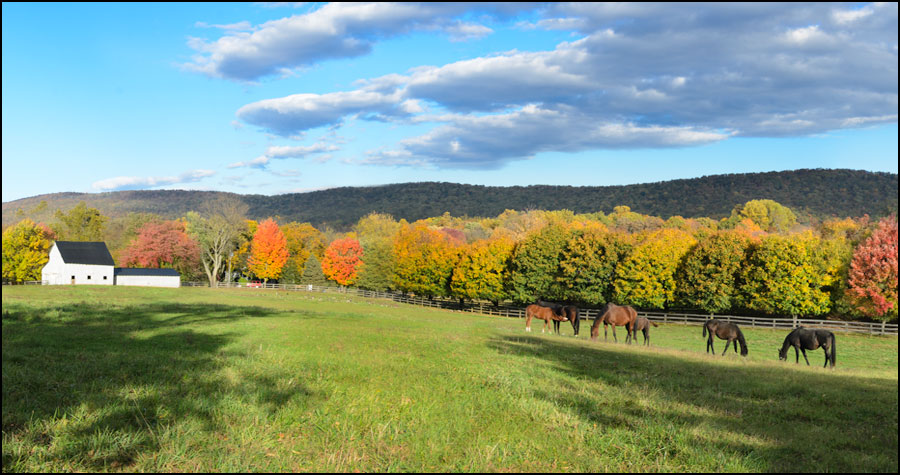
[849,216,897,321]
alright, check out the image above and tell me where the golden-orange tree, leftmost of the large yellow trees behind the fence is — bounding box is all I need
[394,223,459,297]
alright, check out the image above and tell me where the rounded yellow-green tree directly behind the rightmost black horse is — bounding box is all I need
[738,235,830,315]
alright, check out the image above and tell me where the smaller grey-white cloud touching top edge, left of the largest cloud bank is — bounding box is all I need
[184,2,536,81]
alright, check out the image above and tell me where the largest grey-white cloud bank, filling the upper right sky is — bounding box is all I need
[230,0,897,168]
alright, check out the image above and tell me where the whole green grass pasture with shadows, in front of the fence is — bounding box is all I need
[2,287,898,473]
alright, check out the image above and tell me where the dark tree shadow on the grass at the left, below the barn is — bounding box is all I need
[2,302,316,472]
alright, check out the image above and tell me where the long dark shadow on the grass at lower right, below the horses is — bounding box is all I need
[490,336,897,472]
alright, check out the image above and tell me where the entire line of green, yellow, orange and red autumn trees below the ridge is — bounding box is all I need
[3,198,897,320]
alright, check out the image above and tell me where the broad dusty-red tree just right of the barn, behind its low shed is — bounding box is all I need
[122,221,200,273]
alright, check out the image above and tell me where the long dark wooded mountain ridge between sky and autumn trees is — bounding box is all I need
[3,169,898,230]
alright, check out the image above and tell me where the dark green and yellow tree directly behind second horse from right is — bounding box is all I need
[675,231,750,313]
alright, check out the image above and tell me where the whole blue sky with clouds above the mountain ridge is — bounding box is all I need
[2,3,898,201]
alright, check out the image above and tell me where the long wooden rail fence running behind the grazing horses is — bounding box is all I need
[181,282,898,335]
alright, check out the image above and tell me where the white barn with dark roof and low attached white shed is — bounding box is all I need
[41,241,181,287]
